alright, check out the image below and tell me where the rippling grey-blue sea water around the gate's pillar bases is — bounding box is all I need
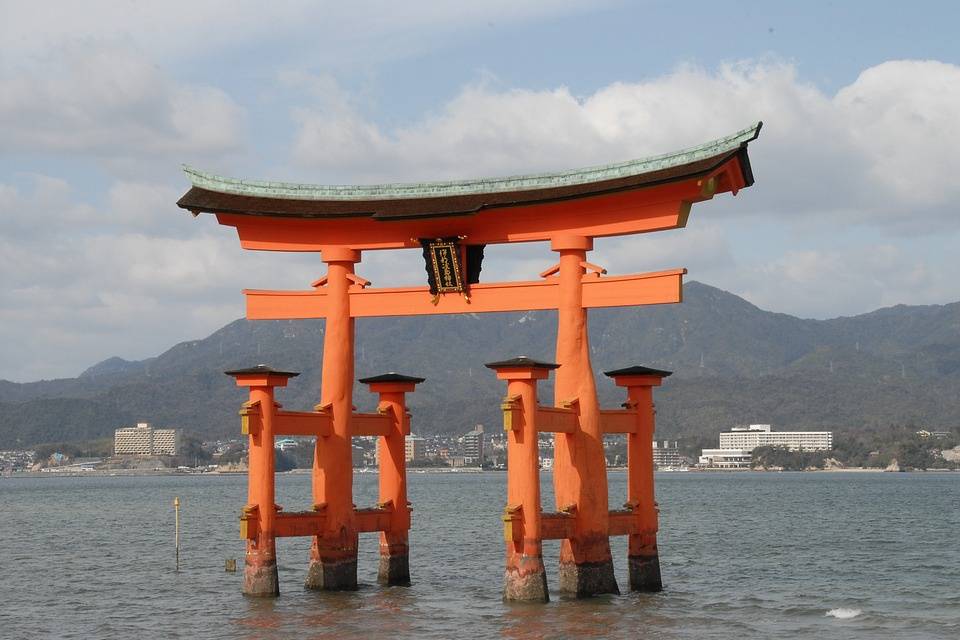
[0,472,960,640]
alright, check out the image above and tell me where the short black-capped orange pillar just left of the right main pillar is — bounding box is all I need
[486,356,558,602]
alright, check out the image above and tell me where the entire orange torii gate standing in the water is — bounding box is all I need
[177,123,761,601]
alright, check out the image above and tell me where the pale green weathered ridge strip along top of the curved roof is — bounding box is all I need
[183,122,763,201]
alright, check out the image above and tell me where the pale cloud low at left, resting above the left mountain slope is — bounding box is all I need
[0,176,323,380]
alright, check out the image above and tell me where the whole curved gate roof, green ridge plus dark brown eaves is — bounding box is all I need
[177,123,763,219]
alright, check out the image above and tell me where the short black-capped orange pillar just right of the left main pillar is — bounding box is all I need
[360,373,424,586]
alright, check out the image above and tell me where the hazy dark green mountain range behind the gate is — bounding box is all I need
[0,282,960,448]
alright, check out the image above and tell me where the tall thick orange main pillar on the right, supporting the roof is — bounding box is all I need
[551,236,620,597]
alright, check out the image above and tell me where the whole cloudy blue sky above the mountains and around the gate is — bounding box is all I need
[0,0,960,382]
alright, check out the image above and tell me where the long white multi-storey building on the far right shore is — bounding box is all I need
[698,424,833,469]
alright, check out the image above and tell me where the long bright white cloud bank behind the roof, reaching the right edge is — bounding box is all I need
[292,61,960,232]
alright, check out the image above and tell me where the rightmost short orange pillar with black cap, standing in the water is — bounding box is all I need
[605,366,671,591]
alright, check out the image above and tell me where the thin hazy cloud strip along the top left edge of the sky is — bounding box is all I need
[0,0,609,65]
